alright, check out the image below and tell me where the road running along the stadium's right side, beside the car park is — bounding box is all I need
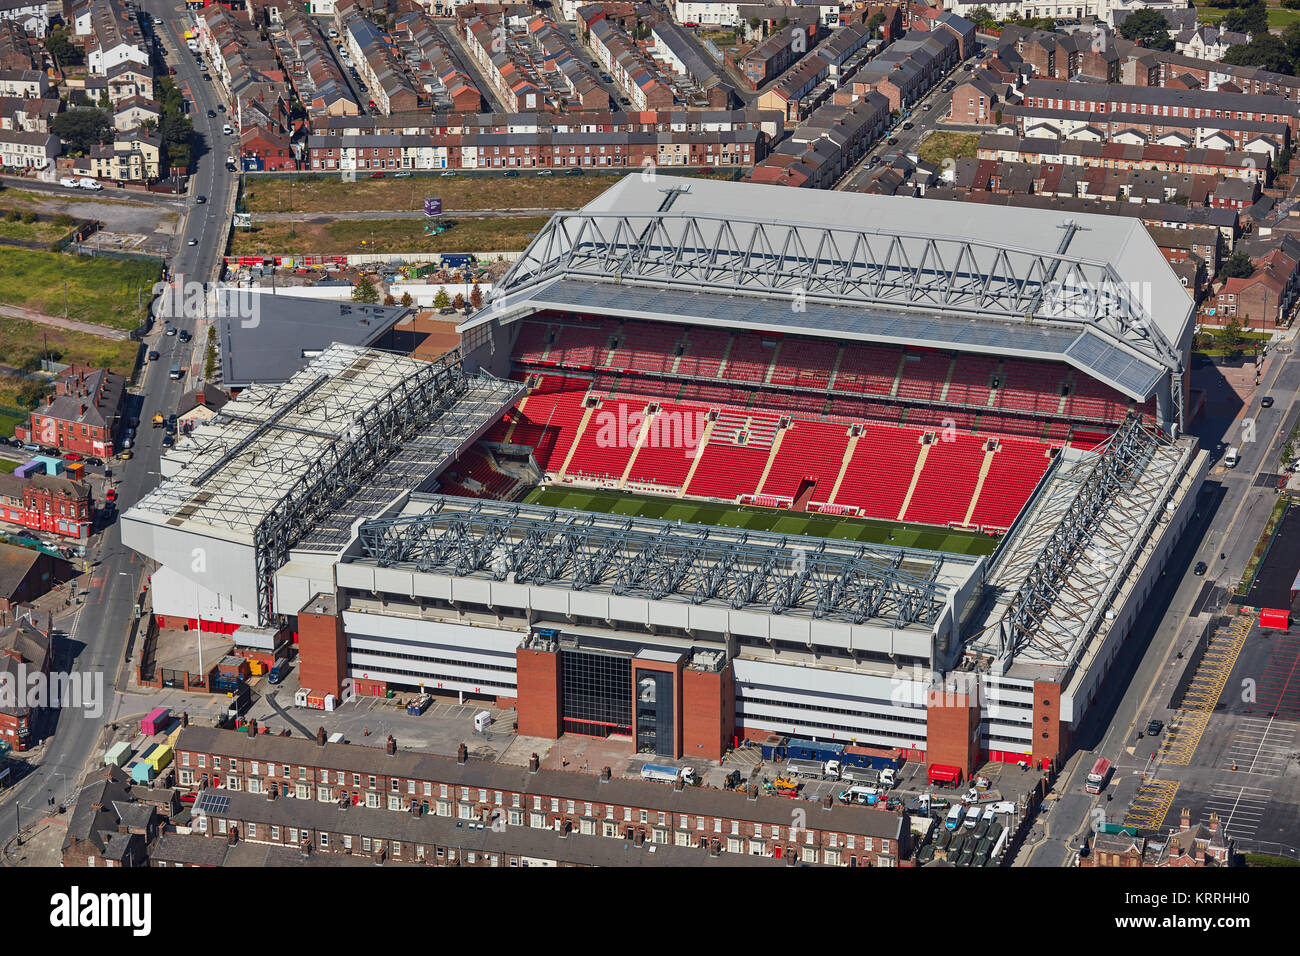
[1017,352,1300,866]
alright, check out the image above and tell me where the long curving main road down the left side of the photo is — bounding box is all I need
[0,0,234,845]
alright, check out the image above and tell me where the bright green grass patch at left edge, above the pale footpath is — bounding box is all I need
[0,248,163,330]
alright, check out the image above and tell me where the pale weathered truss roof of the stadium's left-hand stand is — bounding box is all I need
[124,345,523,620]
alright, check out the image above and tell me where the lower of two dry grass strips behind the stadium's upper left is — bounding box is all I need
[230,216,547,255]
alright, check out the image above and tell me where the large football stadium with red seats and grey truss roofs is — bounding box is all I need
[122,176,1208,774]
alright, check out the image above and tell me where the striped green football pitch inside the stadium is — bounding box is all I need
[524,486,998,554]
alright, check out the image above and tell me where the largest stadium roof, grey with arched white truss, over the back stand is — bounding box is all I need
[460,176,1192,408]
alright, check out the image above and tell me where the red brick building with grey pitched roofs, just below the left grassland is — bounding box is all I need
[14,365,126,458]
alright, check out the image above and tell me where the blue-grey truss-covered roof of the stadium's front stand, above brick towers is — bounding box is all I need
[360,494,983,628]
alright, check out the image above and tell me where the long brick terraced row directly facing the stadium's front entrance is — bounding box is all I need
[176,726,911,866]
